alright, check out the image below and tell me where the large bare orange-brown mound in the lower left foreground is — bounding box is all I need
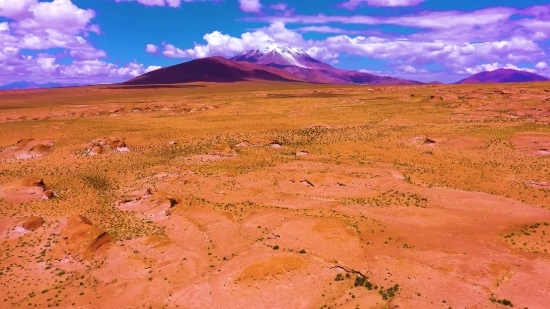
[52,215,114,261]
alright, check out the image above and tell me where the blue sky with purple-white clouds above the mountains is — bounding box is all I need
[0,0,550,84]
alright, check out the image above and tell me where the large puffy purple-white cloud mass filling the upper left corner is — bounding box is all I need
[0,0,157,83]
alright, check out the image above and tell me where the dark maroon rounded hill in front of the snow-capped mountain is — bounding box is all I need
[123,57,301,85]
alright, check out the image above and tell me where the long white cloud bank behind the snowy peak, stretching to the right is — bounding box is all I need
[152,22,545,72]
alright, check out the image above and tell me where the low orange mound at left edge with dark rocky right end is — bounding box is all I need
[0,177,46,202]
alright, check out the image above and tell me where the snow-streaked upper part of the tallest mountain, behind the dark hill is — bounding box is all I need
[231,44,332,69]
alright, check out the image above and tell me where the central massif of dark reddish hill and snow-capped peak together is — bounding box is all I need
[127,45,422,85]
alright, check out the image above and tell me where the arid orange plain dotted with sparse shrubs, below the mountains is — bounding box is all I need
[0,82,550,309]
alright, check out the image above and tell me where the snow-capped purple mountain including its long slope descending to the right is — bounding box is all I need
[231,44,422,85]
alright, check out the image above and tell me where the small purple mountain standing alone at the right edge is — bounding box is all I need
[455,69,550,84]
